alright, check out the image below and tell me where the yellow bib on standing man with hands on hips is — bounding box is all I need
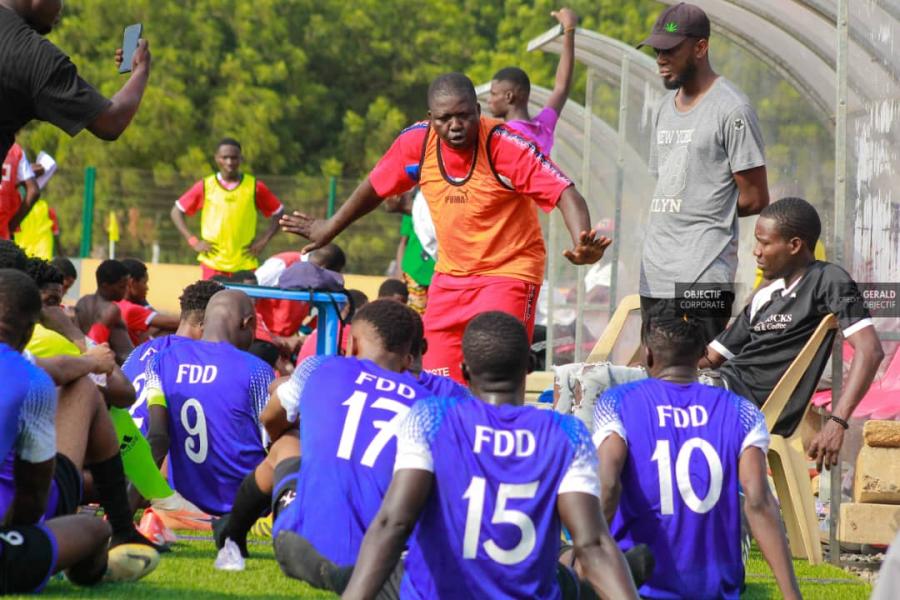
[198,175,259,273]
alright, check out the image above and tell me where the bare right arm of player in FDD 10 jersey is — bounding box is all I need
[738,446,800,600]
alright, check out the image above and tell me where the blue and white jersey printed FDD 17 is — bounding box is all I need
[272,356,427,565]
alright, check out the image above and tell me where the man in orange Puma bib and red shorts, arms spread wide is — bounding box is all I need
[281,73,611,382]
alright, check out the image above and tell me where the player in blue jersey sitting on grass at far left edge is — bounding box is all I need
[0,269,159,593]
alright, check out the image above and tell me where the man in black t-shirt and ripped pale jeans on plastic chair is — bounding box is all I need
[557,198,884,470]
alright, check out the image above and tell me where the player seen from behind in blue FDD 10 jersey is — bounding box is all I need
[594,307,800,600]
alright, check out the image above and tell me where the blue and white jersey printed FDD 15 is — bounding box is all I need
[395,396,600,599]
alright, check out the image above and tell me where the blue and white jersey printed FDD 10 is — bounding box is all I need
[594,379,769,600]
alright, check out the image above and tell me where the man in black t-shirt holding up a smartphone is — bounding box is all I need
[0,0,150,162]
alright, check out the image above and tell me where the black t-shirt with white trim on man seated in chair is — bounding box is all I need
[711,261,871,435]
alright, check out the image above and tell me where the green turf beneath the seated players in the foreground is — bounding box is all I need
[12,532,872,600]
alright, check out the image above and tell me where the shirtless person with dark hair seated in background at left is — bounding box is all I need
[75,260,134,364]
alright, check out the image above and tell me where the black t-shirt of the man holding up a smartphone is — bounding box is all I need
[0,8,110,160]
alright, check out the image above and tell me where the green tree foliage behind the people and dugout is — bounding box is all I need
[17,0,829,268]
